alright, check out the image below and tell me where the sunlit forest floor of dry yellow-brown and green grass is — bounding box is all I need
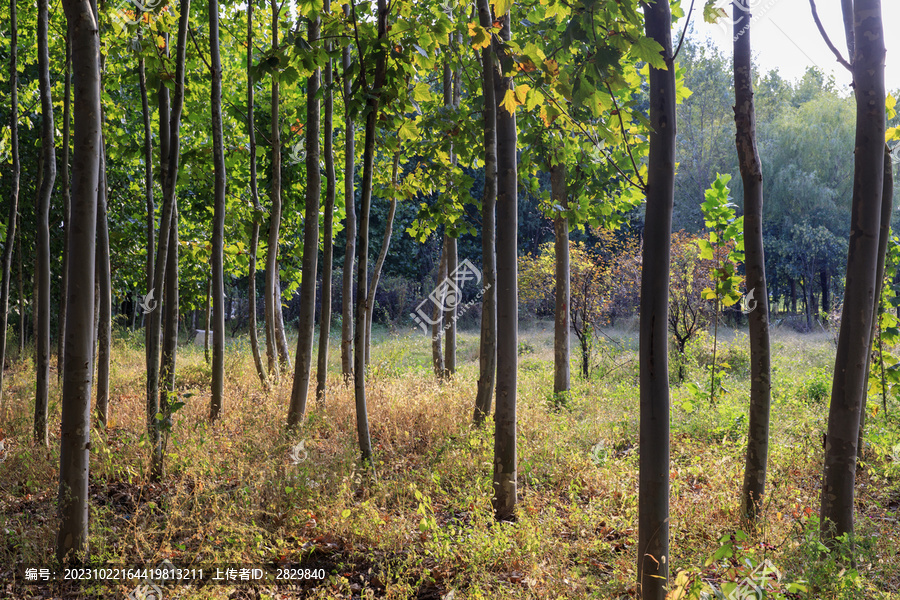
[0,322,900,600]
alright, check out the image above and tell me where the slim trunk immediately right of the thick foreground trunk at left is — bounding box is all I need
[95,142,112,427]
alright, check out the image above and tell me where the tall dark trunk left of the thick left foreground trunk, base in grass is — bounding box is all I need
[34,0,56,446]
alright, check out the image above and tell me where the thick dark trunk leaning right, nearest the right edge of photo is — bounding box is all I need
[820,0,885,541]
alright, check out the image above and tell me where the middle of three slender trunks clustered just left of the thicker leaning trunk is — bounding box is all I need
[265,0,281,383]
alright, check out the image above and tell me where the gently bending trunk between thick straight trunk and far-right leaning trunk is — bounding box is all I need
[734,4,772,523]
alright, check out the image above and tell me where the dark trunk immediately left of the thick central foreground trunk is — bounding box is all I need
[474,0,497,425]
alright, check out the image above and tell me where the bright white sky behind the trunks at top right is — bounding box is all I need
[674,0,900,91]
